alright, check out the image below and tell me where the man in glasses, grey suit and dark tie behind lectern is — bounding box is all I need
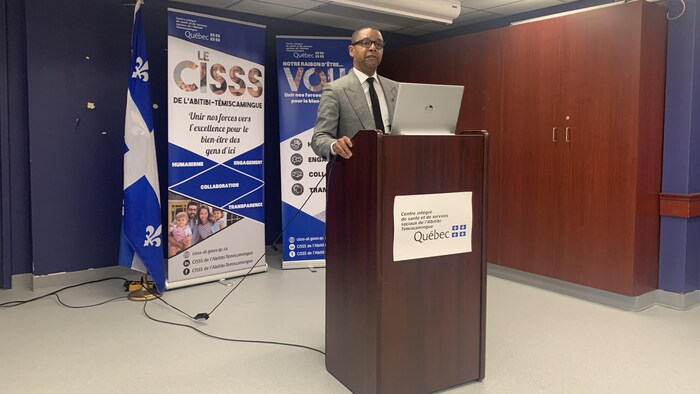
[311,27,399,159]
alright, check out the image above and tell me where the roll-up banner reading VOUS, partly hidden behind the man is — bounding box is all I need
[277,36,352,268]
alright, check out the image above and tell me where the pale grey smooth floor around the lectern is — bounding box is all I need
[0,252,700,393]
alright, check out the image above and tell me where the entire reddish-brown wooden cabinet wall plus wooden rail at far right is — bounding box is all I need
[383,2,668,295]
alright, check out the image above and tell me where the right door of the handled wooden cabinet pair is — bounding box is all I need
[556,2,641,293]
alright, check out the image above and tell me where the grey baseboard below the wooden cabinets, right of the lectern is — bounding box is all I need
[488,264,700,312]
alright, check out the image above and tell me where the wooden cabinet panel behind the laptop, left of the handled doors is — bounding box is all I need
[381,29,503,262]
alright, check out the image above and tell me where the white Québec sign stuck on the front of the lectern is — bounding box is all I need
[394,192,473,261]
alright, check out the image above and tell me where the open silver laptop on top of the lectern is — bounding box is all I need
[390,83,464,135]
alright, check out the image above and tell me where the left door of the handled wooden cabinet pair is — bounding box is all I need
[499,19,562,276]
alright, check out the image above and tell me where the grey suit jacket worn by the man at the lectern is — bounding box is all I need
[311,71,399,159]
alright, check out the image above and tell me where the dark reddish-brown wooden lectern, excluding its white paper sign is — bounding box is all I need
[326,130,488,393]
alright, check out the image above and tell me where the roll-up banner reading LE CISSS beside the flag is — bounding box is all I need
[167,9,267,288]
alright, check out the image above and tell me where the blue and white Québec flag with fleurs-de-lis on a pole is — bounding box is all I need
[119,0,165,293]
